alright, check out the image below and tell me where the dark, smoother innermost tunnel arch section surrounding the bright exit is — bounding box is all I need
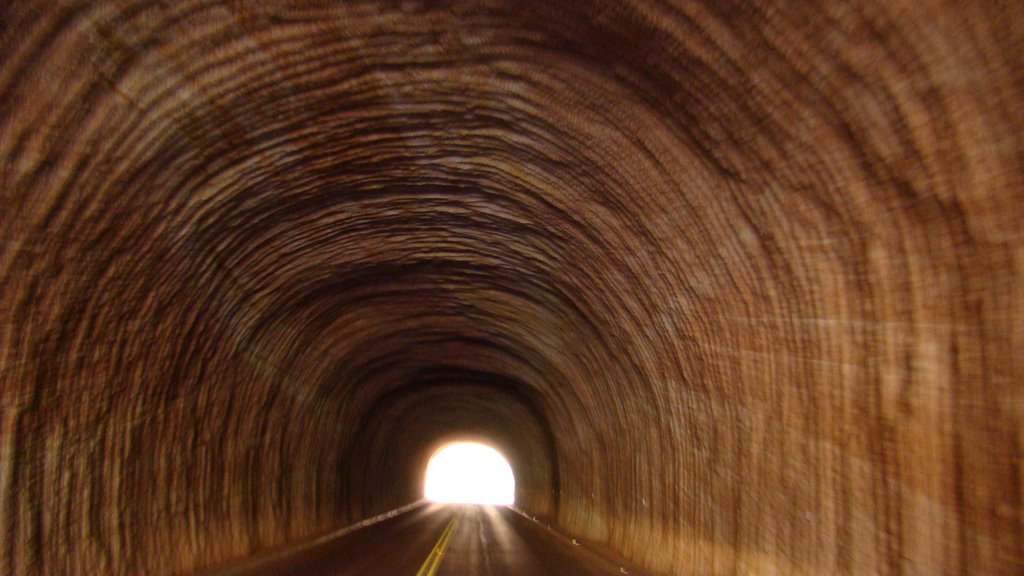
[345,375,560,518]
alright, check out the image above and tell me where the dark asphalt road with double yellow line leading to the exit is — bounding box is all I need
[203,504,623,576]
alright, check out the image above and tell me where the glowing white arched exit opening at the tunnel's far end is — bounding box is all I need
[423,442,515,506]
